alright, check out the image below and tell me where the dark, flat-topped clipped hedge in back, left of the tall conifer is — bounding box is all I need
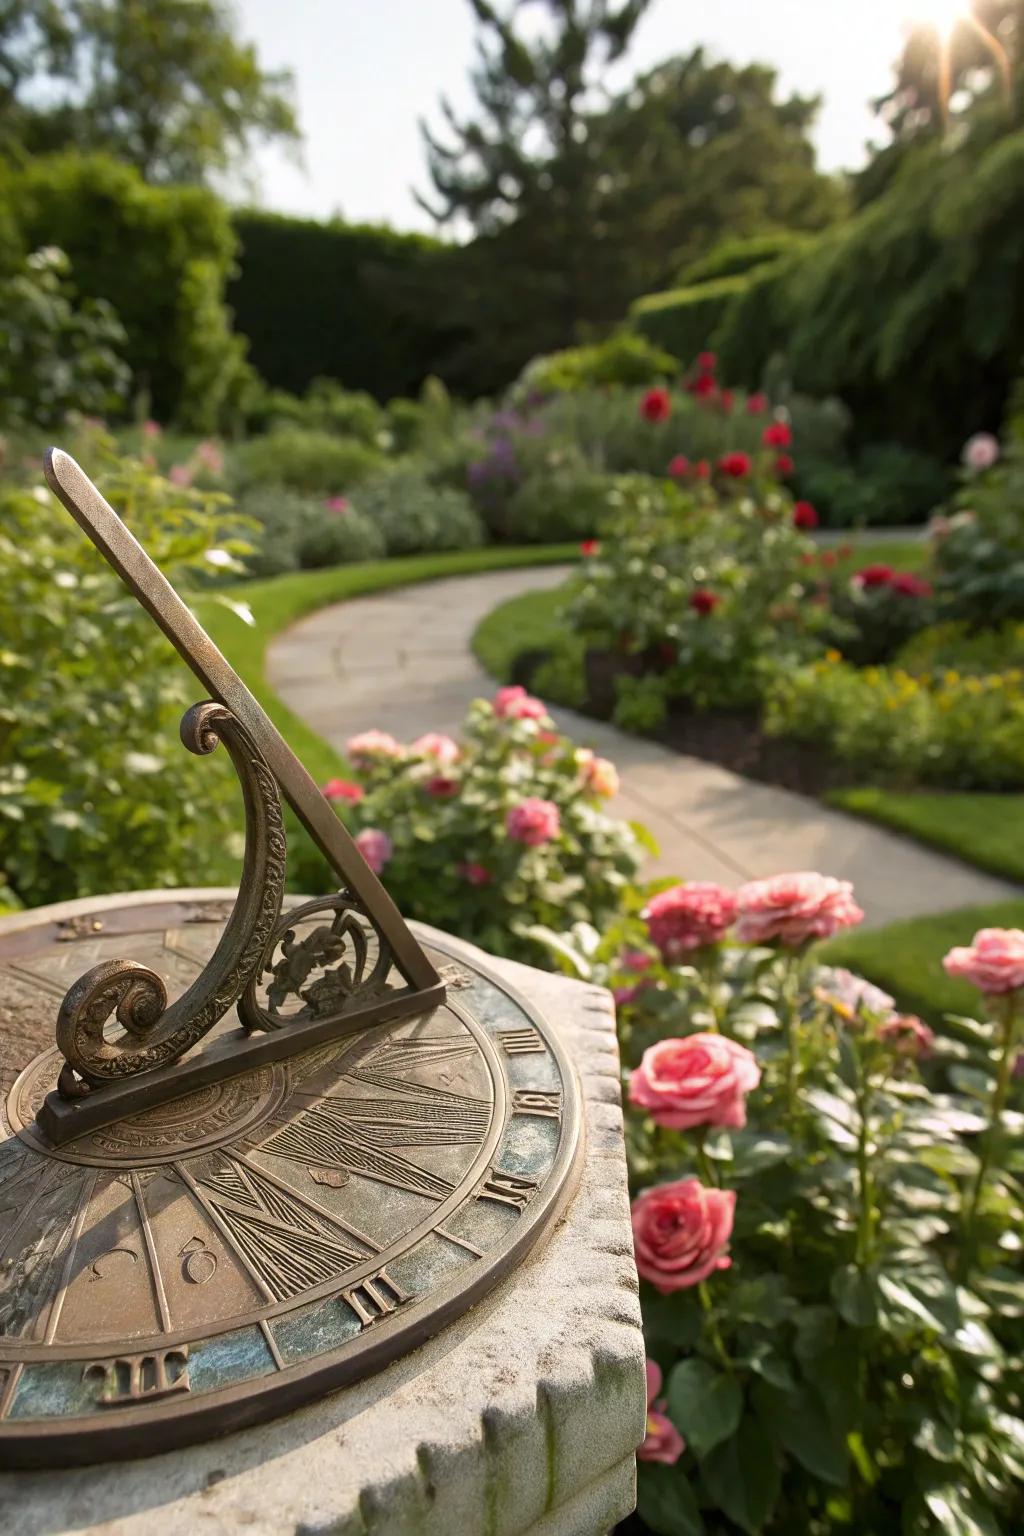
[227,210,450,401]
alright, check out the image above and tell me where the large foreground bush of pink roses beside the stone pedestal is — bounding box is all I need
[557,876,1024,1536]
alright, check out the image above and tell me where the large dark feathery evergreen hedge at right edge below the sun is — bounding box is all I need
[631,129,1024,461]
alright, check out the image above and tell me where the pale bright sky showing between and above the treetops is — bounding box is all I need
[235,0,921,230]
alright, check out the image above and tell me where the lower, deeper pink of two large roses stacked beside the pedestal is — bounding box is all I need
[633,1178,735,1296]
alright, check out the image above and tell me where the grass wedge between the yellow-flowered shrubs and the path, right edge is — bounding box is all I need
[826,788,1024,885]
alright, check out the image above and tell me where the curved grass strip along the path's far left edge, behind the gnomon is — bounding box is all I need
[195,544,579,783]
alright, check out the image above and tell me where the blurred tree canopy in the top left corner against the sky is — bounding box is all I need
[0,0,298,183]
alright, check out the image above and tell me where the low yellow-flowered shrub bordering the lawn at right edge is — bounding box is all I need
[765,651,1024,790]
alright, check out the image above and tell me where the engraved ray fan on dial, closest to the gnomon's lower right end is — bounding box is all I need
[266,1035,490,1200]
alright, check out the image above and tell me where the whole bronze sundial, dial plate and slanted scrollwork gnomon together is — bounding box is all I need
[0,450,580,1467]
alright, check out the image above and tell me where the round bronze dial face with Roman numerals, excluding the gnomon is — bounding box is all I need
[0,894,579,1465]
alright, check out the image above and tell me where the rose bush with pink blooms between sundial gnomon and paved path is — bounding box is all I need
[316,688,640,960]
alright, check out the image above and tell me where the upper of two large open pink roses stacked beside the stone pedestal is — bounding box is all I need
[629,1034,761,1130]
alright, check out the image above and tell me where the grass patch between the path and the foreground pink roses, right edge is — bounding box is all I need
[817,897,1024,1021]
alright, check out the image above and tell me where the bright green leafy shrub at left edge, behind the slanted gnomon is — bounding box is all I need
[0,435,244,906]
